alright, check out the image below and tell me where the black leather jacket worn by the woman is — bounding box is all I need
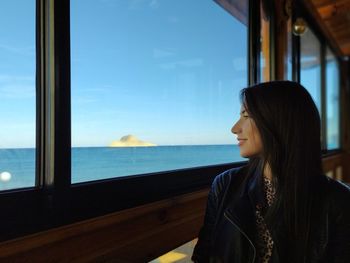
[192,167,350,263]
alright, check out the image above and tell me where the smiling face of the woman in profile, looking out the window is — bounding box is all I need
[231,105,262,158]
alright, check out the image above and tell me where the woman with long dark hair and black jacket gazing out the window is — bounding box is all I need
[192,81,350,263]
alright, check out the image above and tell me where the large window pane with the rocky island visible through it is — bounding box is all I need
[71,0,248,183]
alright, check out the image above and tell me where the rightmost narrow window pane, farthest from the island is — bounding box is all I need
[326,48,340,150]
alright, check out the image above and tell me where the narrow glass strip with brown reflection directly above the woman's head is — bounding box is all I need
[260,1,271,82]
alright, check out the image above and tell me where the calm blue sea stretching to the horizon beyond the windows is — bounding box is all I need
[0,145,245,190]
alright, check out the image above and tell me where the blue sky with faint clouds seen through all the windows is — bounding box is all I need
[0,0,338,148]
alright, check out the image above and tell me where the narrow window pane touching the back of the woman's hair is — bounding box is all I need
[300,26,321,112]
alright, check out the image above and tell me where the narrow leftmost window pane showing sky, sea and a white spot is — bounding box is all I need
[0,0,36,190]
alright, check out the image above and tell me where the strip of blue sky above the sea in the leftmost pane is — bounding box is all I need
[0,0,35,148]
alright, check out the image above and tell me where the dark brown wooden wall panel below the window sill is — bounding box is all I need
[0,190,208,262]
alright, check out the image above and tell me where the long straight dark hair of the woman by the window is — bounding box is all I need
[241,81,322,262]
